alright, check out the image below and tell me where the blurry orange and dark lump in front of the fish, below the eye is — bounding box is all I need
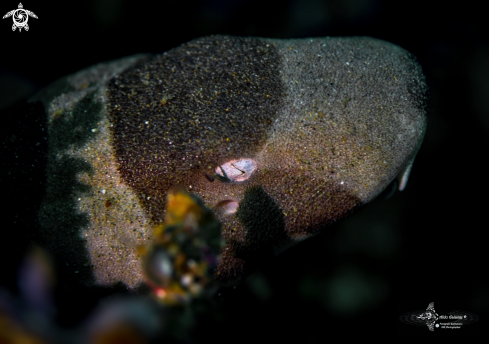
[140,189,222,304]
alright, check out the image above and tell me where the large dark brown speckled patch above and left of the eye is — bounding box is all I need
[107,36,285,222]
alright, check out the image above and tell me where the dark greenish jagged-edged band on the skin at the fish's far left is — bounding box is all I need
[39,91,102,285]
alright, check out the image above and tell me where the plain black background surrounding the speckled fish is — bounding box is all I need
[0,0,489,342]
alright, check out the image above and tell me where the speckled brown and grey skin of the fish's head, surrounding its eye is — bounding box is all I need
[31,36,427,288]
